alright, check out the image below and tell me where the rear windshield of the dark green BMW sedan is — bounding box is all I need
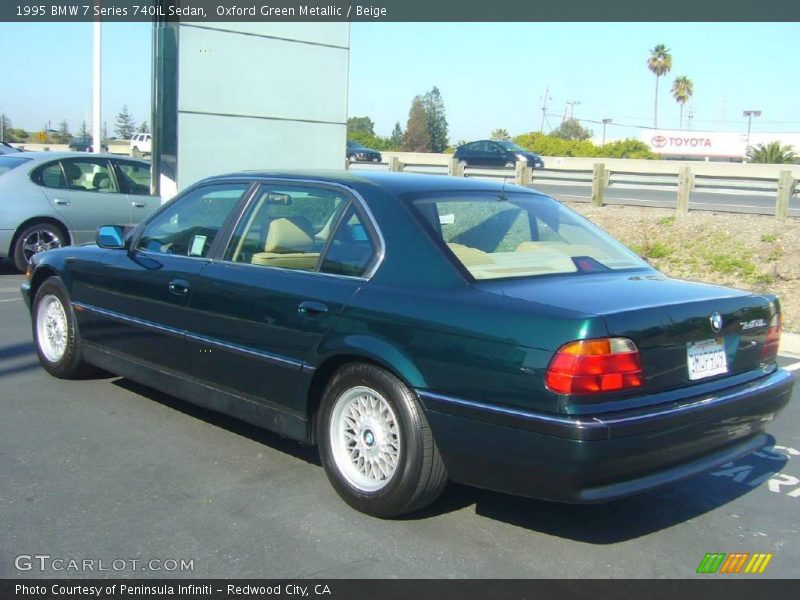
[412,193,649,280]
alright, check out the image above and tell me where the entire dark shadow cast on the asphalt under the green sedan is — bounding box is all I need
[112,378,786,545]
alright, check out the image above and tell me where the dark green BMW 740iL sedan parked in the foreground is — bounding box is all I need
[23,172,793,517]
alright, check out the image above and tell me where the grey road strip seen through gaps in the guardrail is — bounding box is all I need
[350,163,800,217]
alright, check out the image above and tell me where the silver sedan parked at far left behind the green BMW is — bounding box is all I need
[0,152,161,272]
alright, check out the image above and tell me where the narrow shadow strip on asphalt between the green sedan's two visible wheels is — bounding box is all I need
[111,377,322,466]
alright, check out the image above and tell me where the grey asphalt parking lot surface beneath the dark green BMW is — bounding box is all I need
[0,263,800,579]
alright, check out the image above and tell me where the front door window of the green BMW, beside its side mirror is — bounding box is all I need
[136,183,250,258]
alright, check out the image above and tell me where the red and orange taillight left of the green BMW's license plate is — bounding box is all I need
[545,338,644,395]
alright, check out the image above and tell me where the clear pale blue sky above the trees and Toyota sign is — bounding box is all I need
[0,23,800,142]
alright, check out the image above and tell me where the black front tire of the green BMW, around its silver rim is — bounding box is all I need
[31,277,93,379]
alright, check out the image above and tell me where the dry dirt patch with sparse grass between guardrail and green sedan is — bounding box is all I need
[566,202,800,332]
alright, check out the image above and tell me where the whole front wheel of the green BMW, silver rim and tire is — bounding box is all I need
[33,277,91,379]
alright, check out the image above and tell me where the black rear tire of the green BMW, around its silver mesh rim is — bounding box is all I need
[316,363,447,518]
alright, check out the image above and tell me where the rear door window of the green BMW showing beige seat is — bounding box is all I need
[225,184,348,271]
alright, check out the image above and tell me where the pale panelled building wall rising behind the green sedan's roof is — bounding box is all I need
[175,23,350,191]
